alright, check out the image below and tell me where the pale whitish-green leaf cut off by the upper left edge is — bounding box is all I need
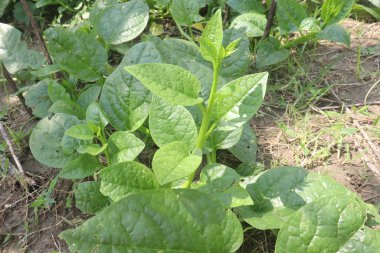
[0,23,45,74]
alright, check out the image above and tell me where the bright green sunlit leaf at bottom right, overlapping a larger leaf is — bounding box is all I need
[276,195,366,253]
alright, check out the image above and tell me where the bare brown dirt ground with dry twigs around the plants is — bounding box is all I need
[0,20,380,253]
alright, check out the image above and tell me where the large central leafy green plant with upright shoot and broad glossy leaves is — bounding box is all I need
[31,8,380,253]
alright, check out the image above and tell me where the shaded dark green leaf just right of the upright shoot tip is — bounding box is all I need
[220,28,252,81]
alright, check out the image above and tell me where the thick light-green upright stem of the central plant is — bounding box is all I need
[184,62,220,188]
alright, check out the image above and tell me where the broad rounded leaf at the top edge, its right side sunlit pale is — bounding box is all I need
[91,0,149,45]
